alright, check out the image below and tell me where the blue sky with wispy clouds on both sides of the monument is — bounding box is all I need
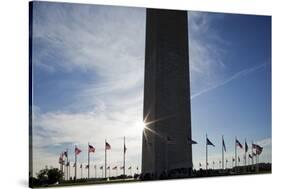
[32,2,271,176]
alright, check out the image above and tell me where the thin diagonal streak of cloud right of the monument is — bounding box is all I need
[191,63,266,99]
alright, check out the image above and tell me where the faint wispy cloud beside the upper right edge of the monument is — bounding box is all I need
[188,12,231,94]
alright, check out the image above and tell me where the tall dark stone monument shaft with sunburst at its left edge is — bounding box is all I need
[142,9,192,179]
